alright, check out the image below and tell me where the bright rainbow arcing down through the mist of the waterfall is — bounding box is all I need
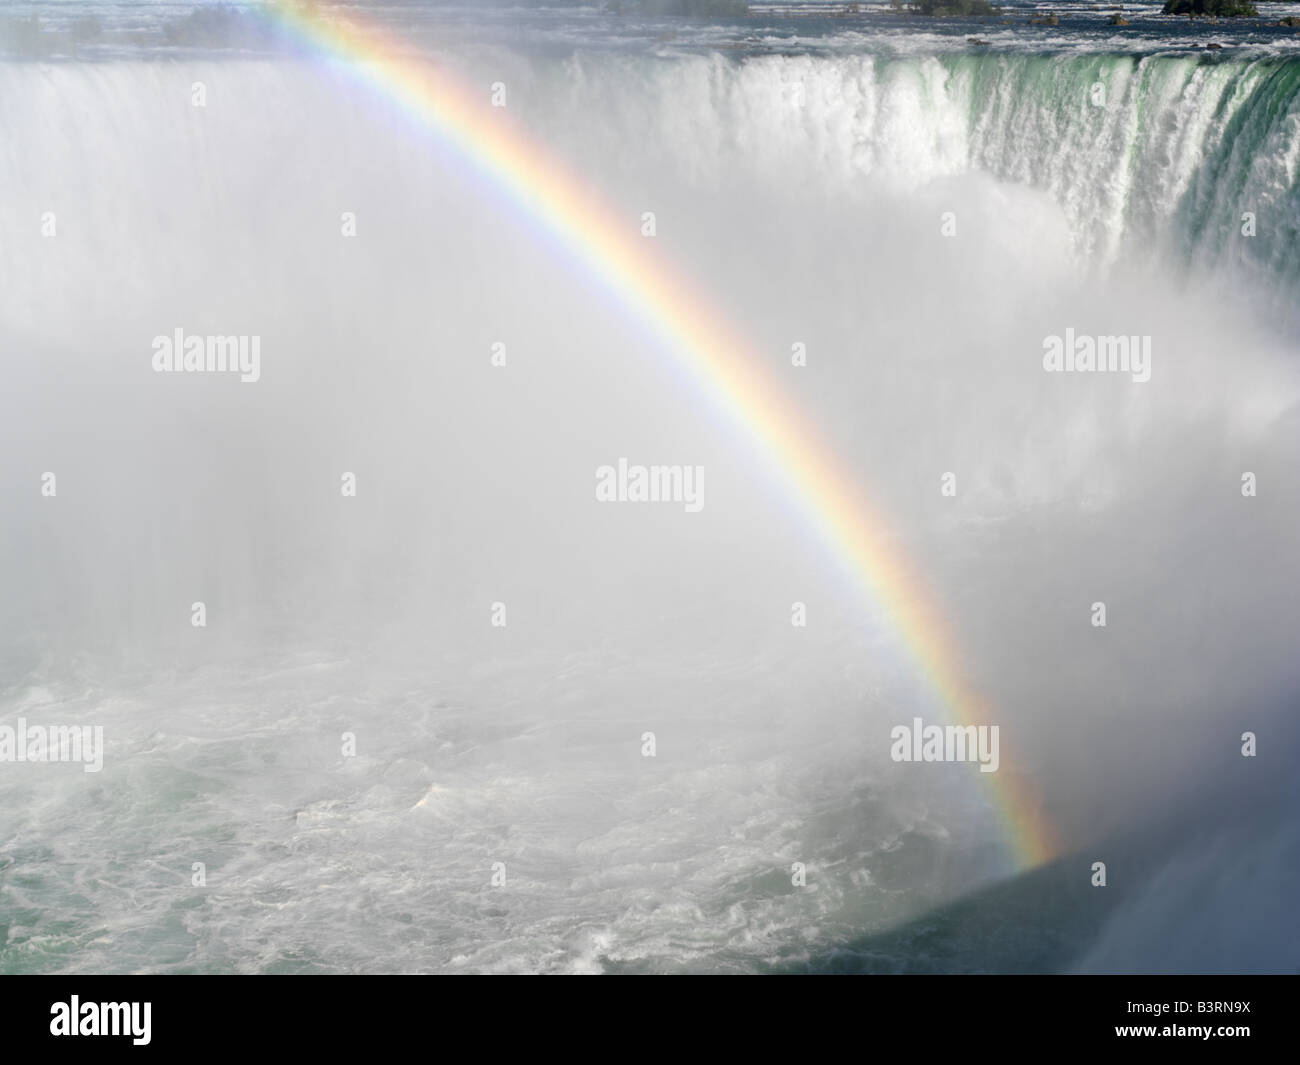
[256,0,1057,869]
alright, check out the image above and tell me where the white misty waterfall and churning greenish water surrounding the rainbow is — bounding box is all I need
[0,4,1300,971]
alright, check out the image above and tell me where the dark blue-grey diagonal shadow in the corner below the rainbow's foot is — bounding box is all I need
[763,775,1300,974]
